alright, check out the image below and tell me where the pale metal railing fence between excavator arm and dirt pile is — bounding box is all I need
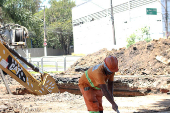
[24,56,81,72]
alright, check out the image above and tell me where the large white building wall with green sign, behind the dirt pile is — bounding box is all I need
[72,0,167,54]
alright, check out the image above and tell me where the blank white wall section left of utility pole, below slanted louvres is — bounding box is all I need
[73,17,113,54]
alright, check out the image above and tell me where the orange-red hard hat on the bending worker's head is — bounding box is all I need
[104,56,119,72]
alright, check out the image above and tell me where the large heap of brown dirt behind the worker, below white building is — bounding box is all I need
[65,38,170,75]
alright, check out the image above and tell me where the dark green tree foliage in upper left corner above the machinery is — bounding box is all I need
[0,0,41,25]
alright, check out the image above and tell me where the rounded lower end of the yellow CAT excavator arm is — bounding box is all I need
[42,73,59,93]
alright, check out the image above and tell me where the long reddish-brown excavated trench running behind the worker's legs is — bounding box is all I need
[12,83,169,97]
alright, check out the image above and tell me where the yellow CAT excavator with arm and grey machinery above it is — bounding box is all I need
[0,24,59,95]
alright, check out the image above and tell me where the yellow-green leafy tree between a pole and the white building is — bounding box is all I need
[46,0,75,54]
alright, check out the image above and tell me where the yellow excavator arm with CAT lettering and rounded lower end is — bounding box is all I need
[0,41,59,95]
